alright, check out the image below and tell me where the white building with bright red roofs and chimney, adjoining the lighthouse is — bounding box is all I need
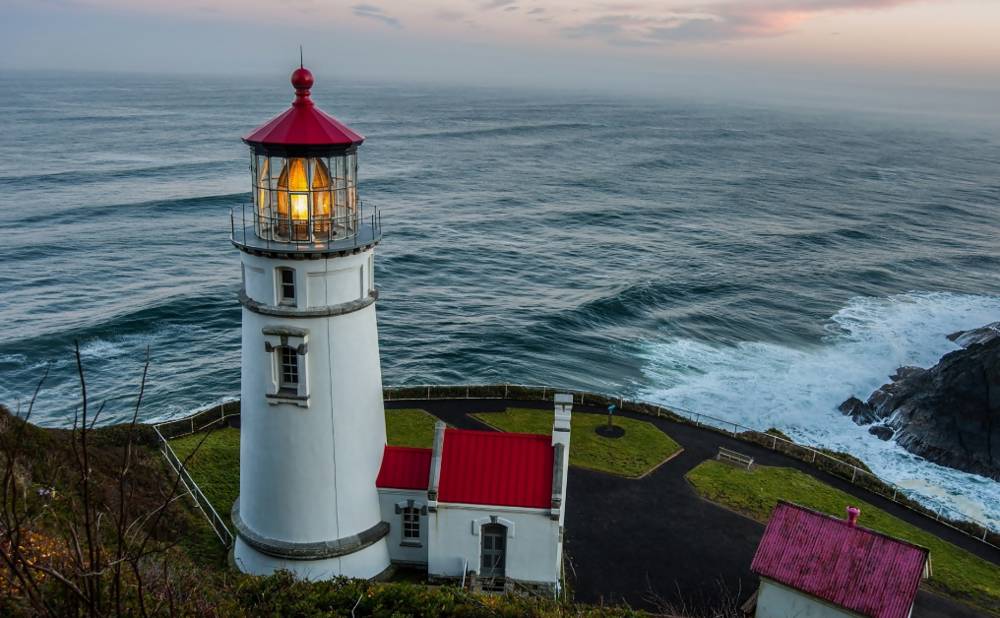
[376,395,573,592]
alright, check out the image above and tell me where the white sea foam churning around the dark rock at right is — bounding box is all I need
[642,292,1000,528]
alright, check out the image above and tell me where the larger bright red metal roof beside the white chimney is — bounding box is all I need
[438,428,553,508]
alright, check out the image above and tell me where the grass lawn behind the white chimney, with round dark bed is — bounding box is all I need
[472,408,681,478]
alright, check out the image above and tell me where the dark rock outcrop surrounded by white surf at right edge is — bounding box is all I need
[839,322,1000,480]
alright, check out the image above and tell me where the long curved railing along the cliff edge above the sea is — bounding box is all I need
[155,383,1000,549]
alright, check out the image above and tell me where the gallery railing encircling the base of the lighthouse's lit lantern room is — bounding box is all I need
[229,200,382,251]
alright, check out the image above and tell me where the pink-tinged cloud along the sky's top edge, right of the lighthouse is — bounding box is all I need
[561,0,919,46]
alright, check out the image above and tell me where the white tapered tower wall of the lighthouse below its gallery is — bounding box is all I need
[233,248,389,579]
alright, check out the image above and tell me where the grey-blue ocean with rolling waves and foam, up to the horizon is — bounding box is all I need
[0,73,1000,526]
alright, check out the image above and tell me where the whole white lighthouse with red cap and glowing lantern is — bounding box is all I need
[232,67,389,579]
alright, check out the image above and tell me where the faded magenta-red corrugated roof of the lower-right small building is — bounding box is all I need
[750,502,927,618]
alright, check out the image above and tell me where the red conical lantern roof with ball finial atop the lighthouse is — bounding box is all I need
[243,67,365,149]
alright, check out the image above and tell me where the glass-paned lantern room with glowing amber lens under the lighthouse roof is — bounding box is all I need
[250,153,359,243]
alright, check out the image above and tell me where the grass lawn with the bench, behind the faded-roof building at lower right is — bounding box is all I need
[687,460,1000,615]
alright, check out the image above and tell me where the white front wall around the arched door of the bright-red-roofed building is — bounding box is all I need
[427,504,562,585]
